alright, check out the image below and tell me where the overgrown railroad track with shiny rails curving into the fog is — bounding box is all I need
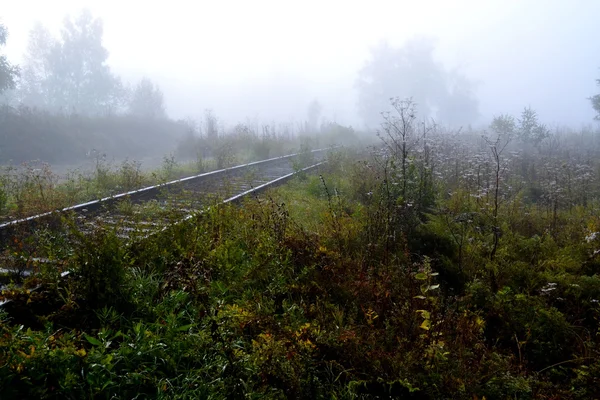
[0,148,331,290]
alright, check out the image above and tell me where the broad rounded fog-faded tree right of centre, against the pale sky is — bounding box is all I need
[356,39,478,125]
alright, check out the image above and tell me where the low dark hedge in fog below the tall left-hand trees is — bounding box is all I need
[0,107,188,164]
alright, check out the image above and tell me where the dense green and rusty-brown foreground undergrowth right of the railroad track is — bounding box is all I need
[0,139,600,399]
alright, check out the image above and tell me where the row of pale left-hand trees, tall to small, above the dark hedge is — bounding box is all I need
[0,10,167,119]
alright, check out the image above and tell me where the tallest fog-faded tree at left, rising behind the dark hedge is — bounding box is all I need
[21,10,123,114]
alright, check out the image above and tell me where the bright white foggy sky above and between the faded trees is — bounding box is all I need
[0,0,600,127]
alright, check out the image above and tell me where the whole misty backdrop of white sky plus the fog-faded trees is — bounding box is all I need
[0,0,600,166]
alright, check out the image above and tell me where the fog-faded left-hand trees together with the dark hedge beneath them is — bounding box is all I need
[0,10,187,164]
